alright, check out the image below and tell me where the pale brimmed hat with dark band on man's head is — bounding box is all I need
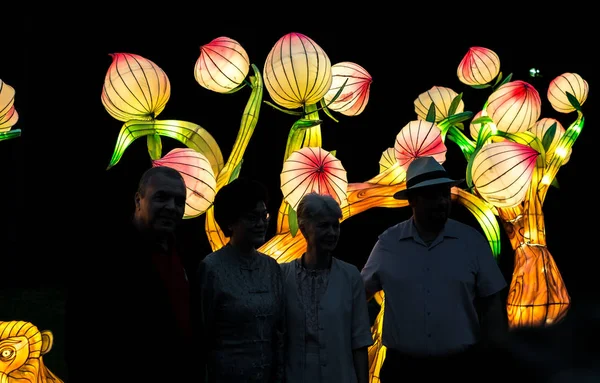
[394,156,464,199]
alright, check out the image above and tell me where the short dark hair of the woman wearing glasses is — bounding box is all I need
[213,177,269,237]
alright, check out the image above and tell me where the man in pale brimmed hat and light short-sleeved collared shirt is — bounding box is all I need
[361,156,507,383]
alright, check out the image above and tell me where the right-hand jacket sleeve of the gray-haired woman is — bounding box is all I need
[352,269,373,350]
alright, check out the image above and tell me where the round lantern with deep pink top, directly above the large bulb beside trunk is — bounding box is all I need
[486,80,542,133]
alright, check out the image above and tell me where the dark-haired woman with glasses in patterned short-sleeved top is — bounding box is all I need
[193,178,285,383]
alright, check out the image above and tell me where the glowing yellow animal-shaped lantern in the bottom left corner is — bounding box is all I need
[0,321,63,383]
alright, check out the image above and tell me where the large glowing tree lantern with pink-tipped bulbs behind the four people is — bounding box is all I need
[103,32,588,383]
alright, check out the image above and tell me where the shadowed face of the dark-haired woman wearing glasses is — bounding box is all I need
[231,201,270,248]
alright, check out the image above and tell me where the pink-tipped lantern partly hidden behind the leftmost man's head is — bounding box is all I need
[152,148,217,218]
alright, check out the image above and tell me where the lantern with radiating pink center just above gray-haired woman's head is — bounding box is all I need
[280,147,348,210]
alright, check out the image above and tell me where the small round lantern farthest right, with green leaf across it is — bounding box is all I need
[548,73,589,113]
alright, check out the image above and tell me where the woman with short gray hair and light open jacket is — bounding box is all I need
[281,193,373,383]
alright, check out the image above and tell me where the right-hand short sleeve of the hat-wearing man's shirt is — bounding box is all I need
[471,233,506,297]
